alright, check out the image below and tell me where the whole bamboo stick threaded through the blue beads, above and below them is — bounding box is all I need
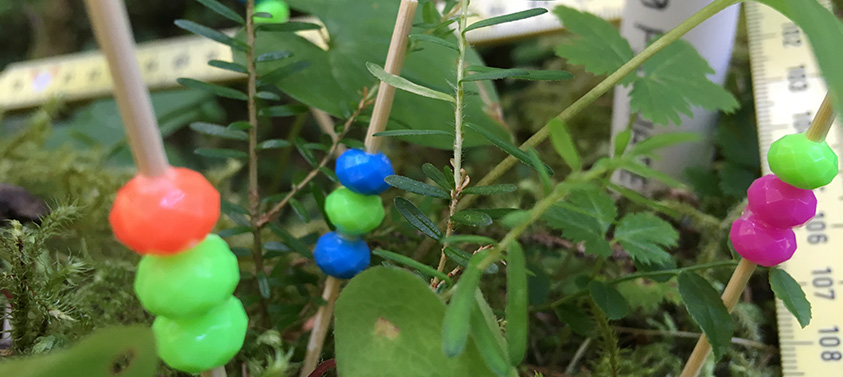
[300,0,419,377]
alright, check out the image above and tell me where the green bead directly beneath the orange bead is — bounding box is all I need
[135,234,240,318]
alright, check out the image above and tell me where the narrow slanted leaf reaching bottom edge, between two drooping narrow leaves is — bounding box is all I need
[469,289,514,377]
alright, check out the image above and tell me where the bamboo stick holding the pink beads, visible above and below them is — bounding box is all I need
[680,93,835,377]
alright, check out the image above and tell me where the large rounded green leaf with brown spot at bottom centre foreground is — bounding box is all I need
[334,267,494,377]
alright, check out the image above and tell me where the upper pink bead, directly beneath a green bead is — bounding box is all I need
[746,174,817,228]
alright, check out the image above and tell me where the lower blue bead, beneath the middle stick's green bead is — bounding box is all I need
[313,232,371,279]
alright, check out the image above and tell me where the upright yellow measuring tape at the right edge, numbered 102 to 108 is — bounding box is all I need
[745,1,843,377]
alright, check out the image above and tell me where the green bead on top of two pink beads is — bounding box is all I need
[767,134,839,190]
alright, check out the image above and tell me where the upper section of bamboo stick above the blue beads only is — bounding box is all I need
[365,0,419,153]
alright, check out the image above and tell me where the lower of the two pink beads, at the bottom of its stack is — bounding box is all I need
[729,211,796,267]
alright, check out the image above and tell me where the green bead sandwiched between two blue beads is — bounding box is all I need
[325,187,384,236]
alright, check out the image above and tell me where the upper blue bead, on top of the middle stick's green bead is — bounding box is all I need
[334,149,395,195]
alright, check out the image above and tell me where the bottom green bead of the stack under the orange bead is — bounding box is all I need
[152,296,249,373]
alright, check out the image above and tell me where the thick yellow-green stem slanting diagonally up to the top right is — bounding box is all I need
[457,0,738,209]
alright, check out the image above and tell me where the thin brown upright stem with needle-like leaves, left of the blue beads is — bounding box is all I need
[246,0,270,328]
